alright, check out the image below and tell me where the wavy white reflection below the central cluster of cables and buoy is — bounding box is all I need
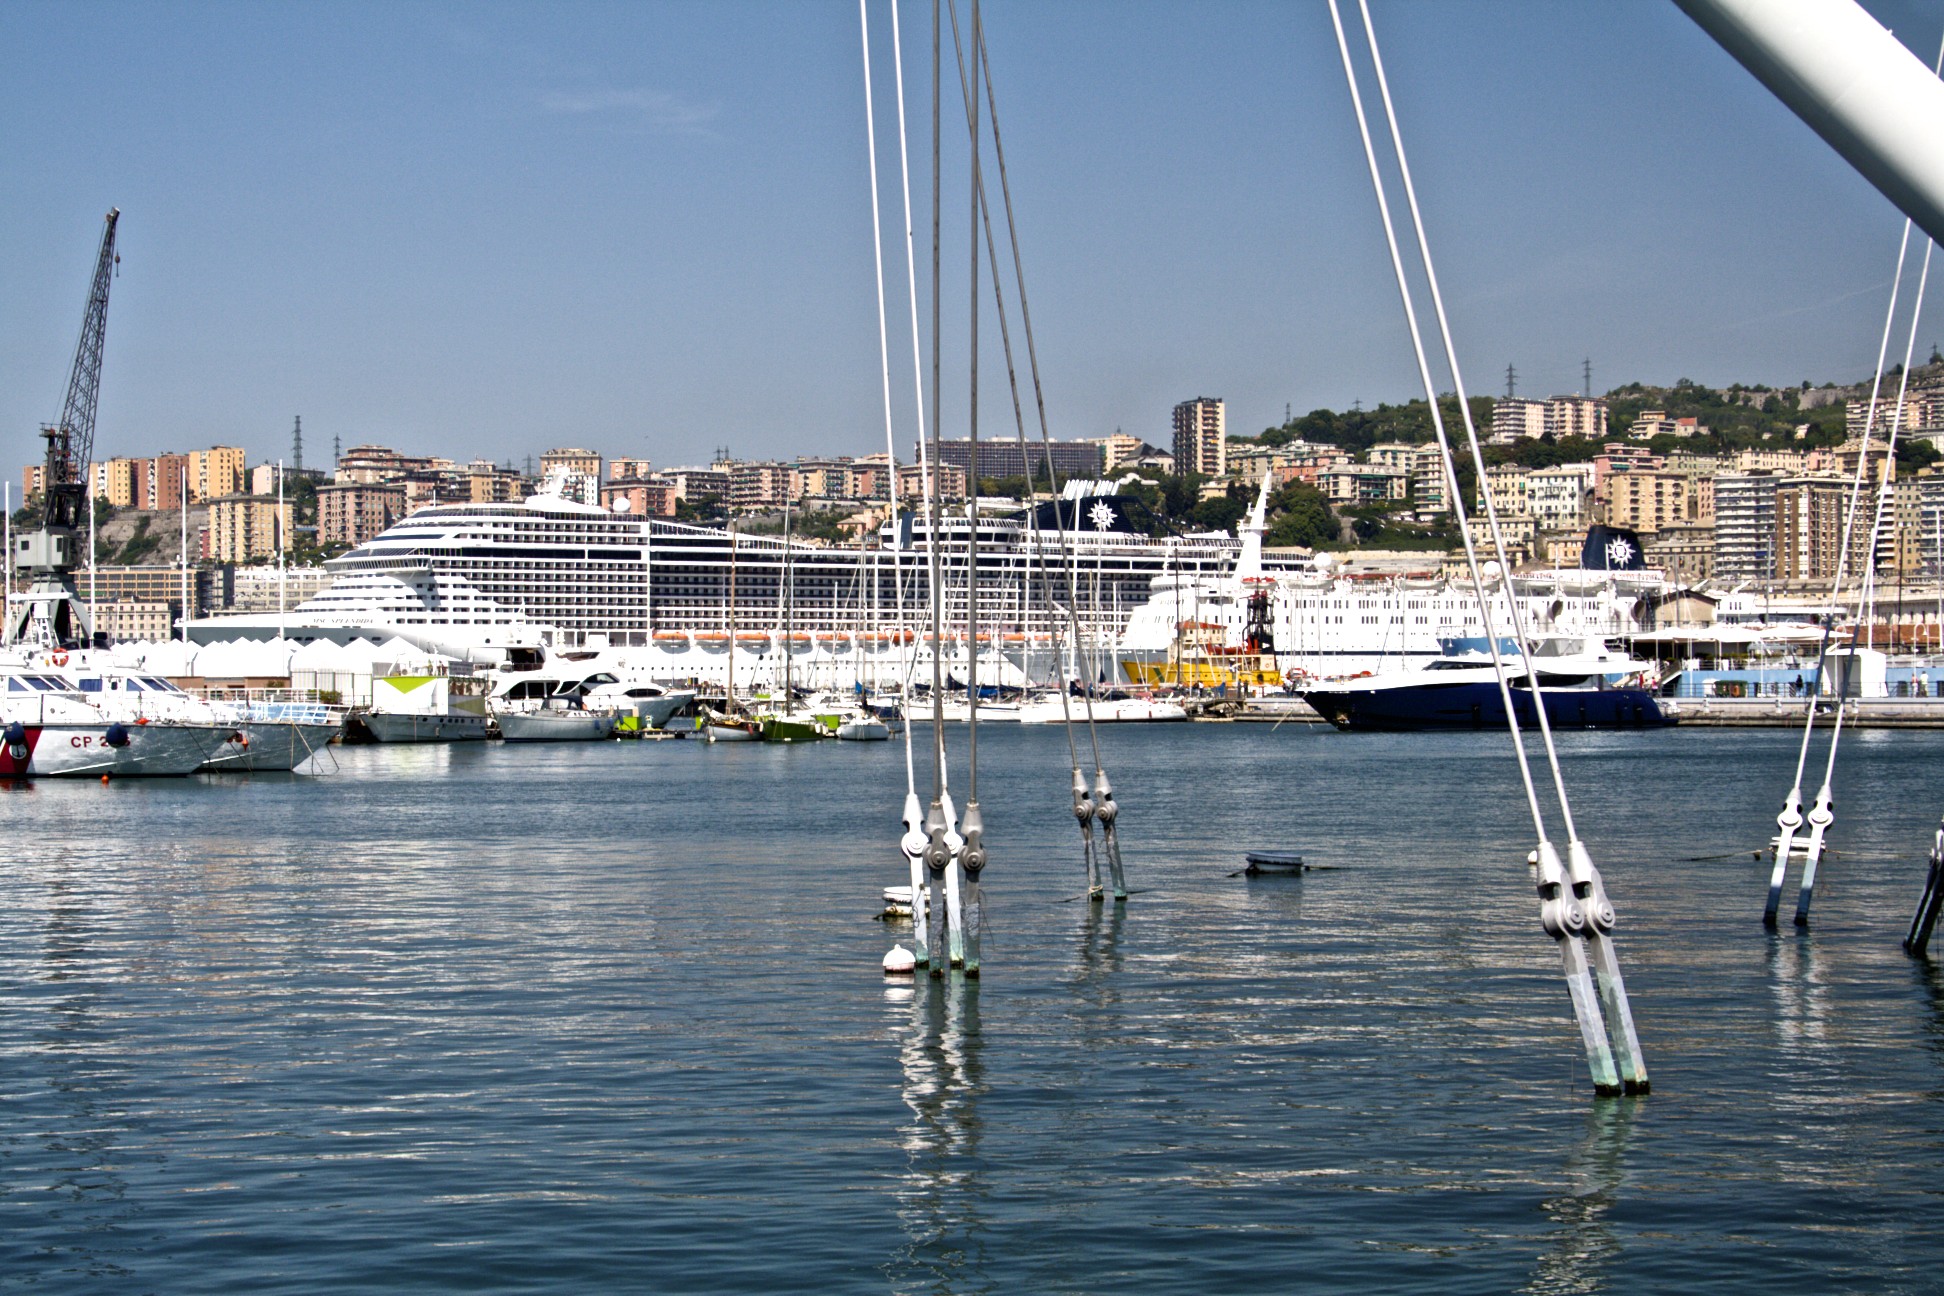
[885,972,991,1292]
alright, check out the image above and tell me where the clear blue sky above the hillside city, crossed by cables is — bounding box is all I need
[0,0,1944,476]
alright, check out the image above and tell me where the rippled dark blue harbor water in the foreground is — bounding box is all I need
[0,725,1944,1294]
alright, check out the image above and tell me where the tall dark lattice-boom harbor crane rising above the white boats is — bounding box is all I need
[6,208,121,651]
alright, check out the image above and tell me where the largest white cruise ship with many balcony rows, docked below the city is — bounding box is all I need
[187,482,1295,678]
